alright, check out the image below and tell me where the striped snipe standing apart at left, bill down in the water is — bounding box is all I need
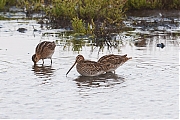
[32,41,56,64]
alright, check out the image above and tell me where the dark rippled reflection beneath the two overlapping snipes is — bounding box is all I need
[74,72,125,87]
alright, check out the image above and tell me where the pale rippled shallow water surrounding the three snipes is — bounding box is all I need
[0,12,180,119]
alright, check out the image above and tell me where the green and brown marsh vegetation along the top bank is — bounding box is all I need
[0,0,180,39]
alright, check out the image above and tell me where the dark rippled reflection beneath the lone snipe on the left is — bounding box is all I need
[32,65,54,78]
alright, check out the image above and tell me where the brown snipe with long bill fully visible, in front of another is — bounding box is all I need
[66,55,105,76]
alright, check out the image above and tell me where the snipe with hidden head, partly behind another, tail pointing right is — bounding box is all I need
[97,54,132,72]
